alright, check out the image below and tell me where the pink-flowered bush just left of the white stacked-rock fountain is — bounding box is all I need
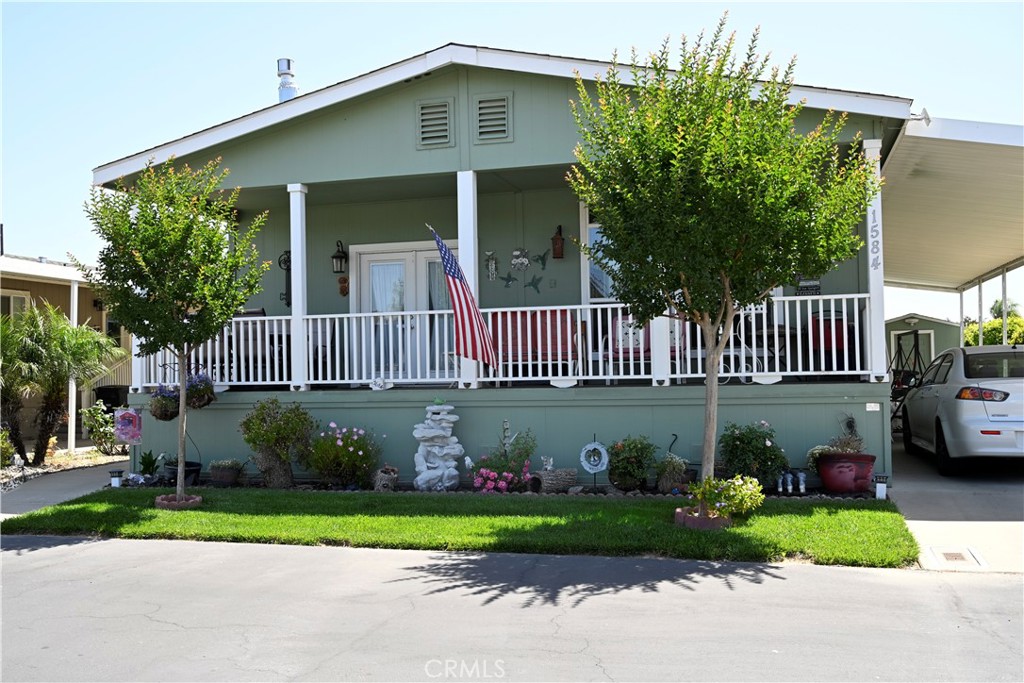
[308,422,387,488]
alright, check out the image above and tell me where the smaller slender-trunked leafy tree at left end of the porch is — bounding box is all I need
[76,158,269,501]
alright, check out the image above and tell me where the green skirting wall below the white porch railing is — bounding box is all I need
[129,382,892,486]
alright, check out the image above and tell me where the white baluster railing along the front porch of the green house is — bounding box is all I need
[136,294,871,387]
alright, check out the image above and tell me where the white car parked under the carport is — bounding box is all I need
[902,345,1024,474]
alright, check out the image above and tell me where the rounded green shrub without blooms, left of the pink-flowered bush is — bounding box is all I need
[241,398,316,488]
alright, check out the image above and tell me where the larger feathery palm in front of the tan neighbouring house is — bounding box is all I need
[15,301,124,467]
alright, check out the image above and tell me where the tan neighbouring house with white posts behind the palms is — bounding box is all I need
[0,254,132,447]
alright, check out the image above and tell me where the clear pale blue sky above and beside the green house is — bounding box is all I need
[0,2,1024,317]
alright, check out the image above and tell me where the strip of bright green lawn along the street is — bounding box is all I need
[0,488,918,567]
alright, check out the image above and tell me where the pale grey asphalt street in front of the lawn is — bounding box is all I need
[0,537,1024,681]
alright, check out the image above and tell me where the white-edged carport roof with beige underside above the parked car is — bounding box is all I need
[882,119,1024,291]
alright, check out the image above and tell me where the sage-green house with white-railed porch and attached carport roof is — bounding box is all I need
[94,44,1024,479]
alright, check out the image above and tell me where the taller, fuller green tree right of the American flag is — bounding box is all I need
[567,16,880,485]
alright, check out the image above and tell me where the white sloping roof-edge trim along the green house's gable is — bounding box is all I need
[92,44,912,184]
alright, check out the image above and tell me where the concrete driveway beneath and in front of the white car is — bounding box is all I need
[889,443,1024,574]
